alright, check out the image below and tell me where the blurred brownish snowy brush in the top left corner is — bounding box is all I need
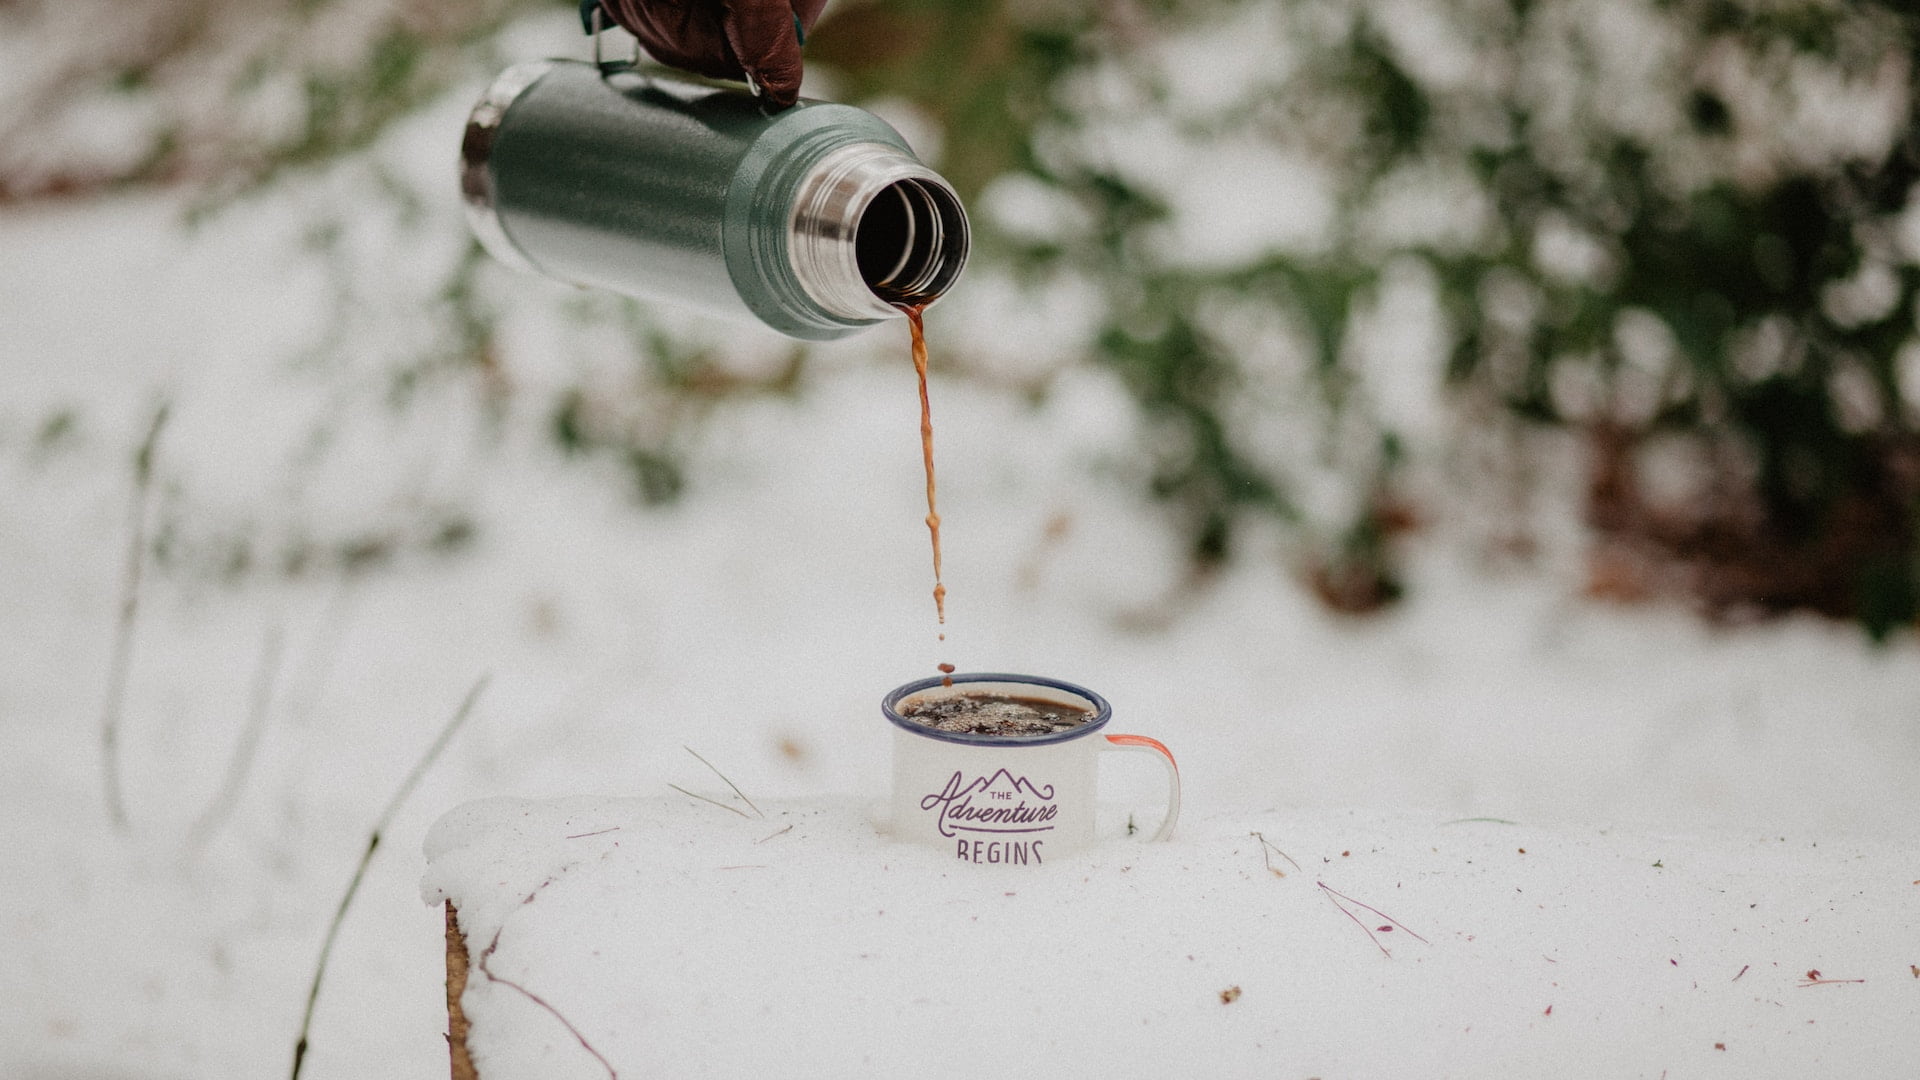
[0,0,538,202]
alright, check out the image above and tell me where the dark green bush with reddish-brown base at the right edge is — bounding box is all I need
[1436,2,1920,636]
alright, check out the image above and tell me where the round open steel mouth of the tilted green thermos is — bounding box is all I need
[854,179,966,304]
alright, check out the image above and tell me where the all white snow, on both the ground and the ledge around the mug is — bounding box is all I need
[0,23,1920,1080]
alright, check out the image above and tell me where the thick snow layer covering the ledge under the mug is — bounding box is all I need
[426,784,1920,1080]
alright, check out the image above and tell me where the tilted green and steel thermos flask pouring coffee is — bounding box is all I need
[461,60,968,340]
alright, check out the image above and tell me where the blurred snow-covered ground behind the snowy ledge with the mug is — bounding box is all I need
[0,73,1920,1080]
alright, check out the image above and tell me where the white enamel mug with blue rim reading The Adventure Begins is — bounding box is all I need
[881,675,1181,867]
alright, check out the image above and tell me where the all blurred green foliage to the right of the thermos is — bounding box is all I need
[816,0,1920,622]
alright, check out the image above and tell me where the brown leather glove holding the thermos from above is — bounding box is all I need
[599,0,828,110]
